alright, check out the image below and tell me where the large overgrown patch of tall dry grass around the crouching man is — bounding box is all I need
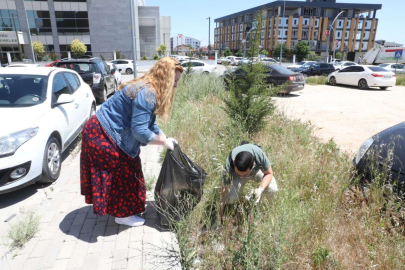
[161,71,405,269]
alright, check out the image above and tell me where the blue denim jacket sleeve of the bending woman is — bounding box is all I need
[131,87,159,145]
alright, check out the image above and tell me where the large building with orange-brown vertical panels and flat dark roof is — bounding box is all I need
[214,0,382,58]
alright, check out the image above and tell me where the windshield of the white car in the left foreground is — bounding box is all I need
[0,74,48,107]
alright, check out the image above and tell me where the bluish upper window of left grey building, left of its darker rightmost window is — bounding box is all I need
[27,10,52,36]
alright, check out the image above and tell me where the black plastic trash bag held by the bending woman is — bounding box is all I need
[155,144,206,227]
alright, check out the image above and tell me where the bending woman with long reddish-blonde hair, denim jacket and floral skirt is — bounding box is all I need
[80,57,183,226]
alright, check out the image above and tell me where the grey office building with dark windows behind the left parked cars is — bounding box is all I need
[0,0,170,61]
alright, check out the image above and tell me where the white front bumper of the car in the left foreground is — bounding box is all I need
[0,134,45,194]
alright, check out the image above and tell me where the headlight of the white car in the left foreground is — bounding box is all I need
[0,127,38,157]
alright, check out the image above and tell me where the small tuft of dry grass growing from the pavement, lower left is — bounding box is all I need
[7,210,40,250]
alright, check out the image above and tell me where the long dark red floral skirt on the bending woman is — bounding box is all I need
[80,116,146,217]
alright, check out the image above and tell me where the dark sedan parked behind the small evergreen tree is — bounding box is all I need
[224,65,305,93]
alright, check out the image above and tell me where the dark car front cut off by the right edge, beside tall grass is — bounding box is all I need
[353,122,405,192]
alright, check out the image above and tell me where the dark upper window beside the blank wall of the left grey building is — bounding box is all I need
[55,11,90,35]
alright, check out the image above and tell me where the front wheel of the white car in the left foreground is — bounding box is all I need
[39,137,62,183]
